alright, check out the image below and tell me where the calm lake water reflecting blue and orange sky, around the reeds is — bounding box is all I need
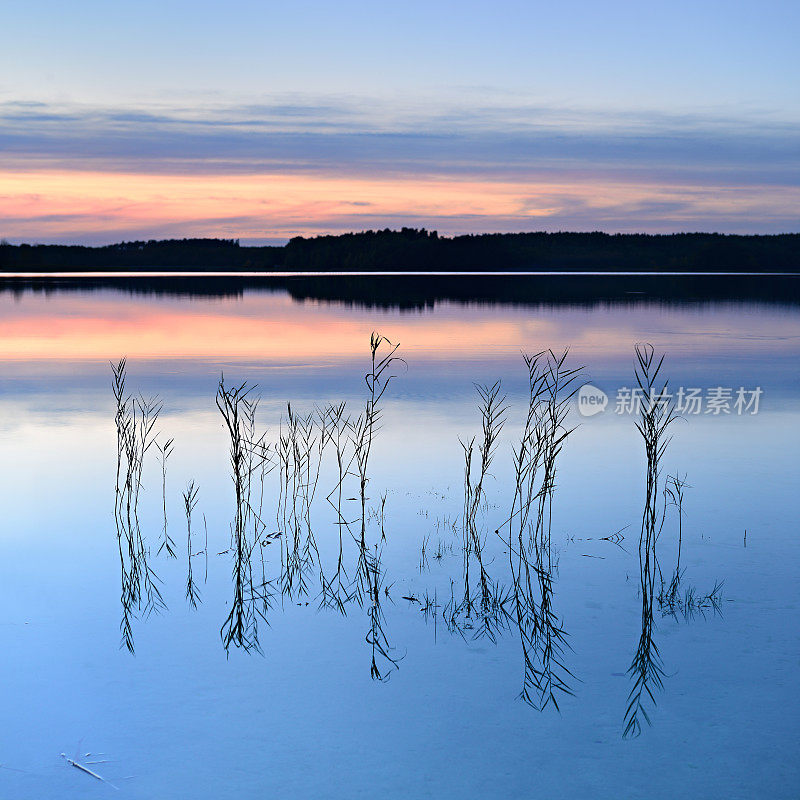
[0,278,800,799]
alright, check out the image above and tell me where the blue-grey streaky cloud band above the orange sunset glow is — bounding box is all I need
[0,100,800,186]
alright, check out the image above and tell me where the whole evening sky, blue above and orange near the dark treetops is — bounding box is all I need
[0,0,800,244]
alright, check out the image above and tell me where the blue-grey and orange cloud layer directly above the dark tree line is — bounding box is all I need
[0,96,800,238]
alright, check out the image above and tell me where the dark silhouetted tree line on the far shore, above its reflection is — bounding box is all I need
[0,228,800,272]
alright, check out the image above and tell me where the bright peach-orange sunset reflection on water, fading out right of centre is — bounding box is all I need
[0,295,549,363]
